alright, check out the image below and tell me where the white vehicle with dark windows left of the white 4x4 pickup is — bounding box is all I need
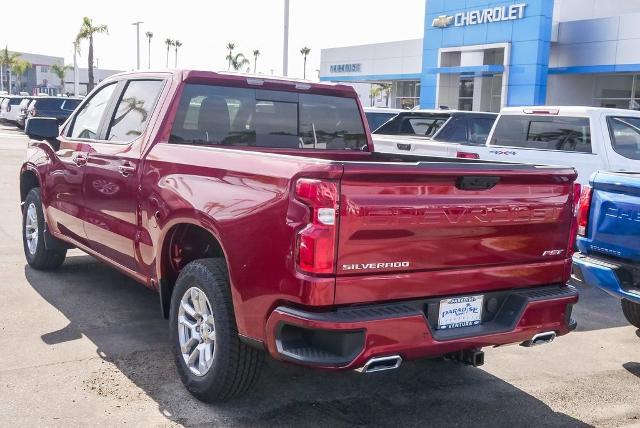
[373,110,498,157]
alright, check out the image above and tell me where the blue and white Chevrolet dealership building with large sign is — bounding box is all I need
[320,0,640,111]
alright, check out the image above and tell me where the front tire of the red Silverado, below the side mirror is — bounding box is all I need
[22,187,67,270]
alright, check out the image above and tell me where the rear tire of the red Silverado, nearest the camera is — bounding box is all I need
[169,259,264,402]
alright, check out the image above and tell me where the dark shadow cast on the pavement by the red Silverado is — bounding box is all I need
[25,256,596,427]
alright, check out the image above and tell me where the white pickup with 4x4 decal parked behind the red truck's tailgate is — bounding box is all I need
[476,107,640,184]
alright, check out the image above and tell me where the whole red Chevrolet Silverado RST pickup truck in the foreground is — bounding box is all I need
[20,71,578,401]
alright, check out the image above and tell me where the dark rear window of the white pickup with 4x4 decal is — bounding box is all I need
[490,115,591,153]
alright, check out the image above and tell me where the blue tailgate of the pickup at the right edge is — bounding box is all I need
[587,173,640,261]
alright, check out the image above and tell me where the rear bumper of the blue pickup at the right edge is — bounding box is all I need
[571,253,640,303]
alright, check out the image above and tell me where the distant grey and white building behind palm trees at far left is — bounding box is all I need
[0,52,120,95]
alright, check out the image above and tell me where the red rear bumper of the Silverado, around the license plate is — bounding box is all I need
[267,286,578,369]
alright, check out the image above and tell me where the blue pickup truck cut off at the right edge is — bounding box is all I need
[573,172,640,328]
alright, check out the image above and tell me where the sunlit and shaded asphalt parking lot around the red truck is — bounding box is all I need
[0,122,640,427]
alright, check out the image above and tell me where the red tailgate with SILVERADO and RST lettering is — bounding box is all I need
[336,163,575,303]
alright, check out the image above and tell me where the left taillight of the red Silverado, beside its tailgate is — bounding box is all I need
[295,178,338,274]
